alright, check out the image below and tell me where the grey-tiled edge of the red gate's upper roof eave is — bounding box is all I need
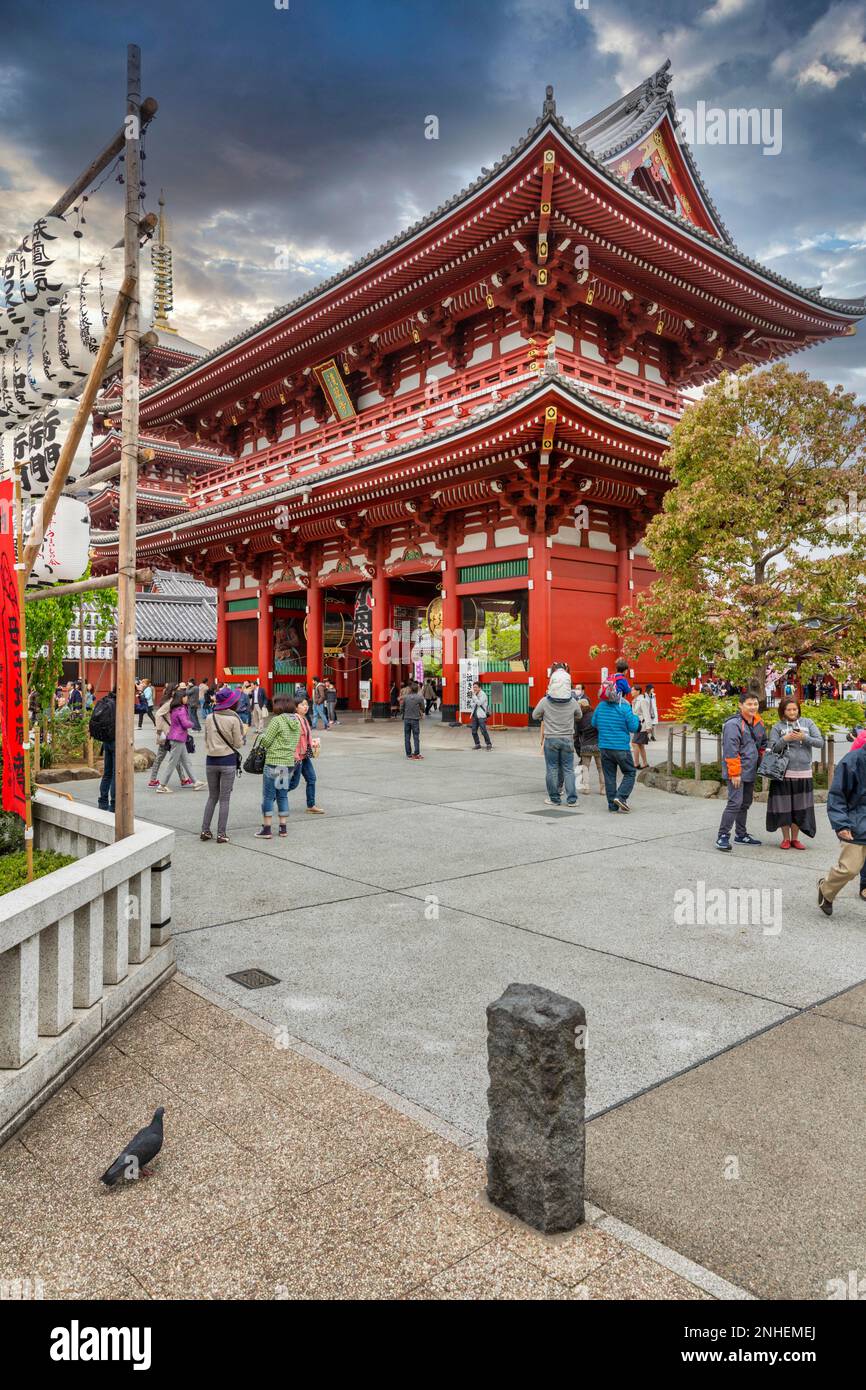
[106,86,866,414]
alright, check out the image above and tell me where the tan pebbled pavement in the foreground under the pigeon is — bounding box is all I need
[0,977,741,1300]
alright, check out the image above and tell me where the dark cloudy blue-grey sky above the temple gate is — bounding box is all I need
[0,0,866,395]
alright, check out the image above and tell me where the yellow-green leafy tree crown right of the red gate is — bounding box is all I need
[609,364,866,695]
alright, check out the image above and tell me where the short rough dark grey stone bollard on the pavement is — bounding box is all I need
[487,984,587,1233]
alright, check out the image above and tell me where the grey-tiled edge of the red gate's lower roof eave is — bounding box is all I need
[92,363,670,549]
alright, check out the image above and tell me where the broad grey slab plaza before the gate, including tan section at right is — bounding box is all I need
[28,719,866,1298]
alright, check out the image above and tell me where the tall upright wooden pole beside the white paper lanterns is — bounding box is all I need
[114,43,142,840]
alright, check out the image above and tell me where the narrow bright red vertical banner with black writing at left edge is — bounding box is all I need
[0,481,25,816]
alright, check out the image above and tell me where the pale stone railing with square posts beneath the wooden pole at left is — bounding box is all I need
[0,791,175,1144]
